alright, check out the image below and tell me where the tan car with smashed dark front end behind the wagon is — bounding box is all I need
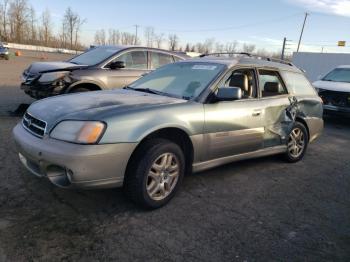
[21,46,187,99]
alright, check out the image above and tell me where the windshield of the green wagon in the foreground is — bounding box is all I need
[130,62,225,99]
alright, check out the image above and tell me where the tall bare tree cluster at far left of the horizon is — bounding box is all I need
[0,0,86,50]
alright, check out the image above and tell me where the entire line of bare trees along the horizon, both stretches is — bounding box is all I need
[0,0,286,57]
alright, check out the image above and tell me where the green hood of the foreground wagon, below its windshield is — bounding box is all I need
[27,89,187,130]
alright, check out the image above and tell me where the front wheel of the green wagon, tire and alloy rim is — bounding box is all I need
[124,139,185,209]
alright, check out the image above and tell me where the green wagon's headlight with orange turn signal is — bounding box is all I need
[50,120,106,144]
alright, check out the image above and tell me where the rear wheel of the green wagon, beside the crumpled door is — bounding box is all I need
[285,122,309,163]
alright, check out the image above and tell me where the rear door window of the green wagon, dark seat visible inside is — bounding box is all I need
[259,69,287,97]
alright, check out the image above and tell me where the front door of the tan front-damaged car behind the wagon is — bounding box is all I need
[104,50,150,88]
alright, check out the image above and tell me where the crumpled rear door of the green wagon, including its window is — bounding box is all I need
[258,68,293,148]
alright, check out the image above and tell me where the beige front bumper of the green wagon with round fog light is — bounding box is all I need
[13,124,137,188]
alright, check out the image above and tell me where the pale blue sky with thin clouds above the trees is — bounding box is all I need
[29,0,350,52]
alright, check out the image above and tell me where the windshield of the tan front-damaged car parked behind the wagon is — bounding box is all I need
[69,47,120,66]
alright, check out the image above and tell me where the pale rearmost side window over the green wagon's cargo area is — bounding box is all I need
[281,71,316,95]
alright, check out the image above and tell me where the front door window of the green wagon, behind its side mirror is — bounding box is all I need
[220,69,257,99]
